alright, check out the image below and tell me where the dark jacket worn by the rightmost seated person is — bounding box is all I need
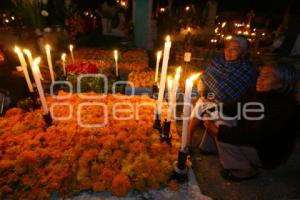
[218,92,299,169]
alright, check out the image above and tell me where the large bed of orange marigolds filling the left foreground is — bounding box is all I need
[0,92,180,199]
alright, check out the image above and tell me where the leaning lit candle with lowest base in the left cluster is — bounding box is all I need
[32,57,49,114]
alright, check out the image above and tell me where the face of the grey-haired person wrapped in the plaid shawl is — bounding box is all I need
[224,40,242,61]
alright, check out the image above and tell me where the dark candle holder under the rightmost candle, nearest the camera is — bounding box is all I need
[171,150,188,183]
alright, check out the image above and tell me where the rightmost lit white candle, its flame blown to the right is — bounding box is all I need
[181,74,200,151]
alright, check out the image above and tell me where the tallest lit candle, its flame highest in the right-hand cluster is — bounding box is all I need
[157,36,172,115]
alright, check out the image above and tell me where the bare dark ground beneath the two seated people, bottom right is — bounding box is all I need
[192,128,300,200]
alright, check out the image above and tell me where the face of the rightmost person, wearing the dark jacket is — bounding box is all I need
[256,66,283,92]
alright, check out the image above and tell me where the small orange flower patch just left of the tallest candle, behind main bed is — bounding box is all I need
[128,71,155,88]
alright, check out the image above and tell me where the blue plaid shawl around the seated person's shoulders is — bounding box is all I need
[201,56,257,103]
